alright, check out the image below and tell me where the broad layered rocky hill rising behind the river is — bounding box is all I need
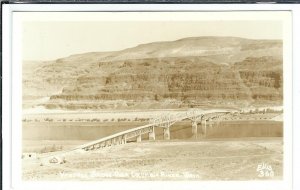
[23,37,283,109]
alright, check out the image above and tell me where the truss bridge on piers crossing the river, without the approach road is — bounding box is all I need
[76,111,233,151]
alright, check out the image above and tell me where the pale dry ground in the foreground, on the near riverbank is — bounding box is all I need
[23,138,283,180]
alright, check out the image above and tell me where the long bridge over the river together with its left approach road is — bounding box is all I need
[40,110,232,161]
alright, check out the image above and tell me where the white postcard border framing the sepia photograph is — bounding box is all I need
[2,5,300,189]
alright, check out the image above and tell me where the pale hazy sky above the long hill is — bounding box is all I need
[22,20,282,60]
